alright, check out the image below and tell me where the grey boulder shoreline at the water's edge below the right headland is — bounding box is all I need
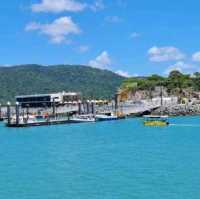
[152,104,200,116]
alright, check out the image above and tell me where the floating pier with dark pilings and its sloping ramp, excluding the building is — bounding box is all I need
[2,100,159,128]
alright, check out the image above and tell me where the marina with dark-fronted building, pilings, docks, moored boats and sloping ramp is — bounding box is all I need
[0,91,159,128]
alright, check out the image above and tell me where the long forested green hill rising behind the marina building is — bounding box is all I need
[0,65,125,103]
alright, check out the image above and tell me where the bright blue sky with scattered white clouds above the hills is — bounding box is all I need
[0,0,200,76]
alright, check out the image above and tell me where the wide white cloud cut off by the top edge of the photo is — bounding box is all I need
[31,0,86,13]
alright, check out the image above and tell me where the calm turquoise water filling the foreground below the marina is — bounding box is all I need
[0,117,200,199]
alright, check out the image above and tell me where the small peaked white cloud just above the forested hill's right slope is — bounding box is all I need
[88,51,112,69]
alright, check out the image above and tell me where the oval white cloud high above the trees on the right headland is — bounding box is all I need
[148,46,185,62]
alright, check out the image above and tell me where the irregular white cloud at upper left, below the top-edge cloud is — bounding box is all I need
[25,17,81,44]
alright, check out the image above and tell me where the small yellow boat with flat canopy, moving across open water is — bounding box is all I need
[144,115,169,126]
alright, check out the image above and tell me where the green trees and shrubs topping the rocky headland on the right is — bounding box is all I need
[121,71,200,101]
